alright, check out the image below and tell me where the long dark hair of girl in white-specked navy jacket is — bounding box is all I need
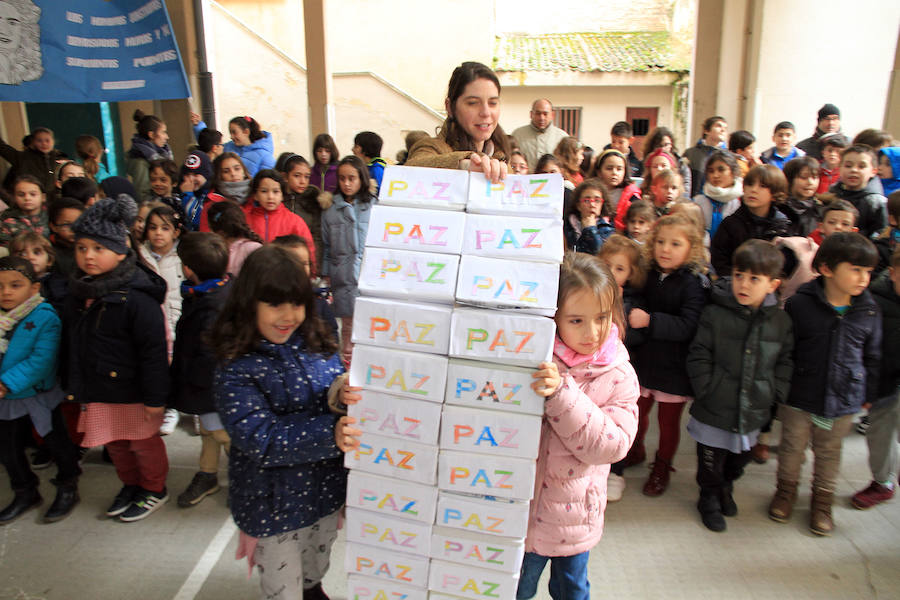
[209,245,337,361]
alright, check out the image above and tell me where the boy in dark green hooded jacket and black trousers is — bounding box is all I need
[687,240,794,531]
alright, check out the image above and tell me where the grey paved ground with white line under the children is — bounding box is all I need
[0,412,900,600]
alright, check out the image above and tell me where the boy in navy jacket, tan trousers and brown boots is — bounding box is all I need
[769,232,881,536]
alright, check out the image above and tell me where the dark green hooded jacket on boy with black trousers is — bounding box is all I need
[687,279,794,434]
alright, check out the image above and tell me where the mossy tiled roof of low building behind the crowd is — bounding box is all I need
[494,31,690,72]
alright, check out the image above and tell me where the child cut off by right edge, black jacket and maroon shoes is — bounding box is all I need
[850,246,900,510]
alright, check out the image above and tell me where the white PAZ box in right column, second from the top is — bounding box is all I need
[462,214,565,263]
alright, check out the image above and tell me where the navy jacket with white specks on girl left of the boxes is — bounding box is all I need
[214,330,347,537]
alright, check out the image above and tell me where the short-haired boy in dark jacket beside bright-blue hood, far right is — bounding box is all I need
[828,145,887,238]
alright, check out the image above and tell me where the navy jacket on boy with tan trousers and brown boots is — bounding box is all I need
[784,277,881,418]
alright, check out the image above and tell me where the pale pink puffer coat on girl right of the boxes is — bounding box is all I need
[525,335,640,556]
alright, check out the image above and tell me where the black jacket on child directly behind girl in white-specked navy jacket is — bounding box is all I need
[169,281,230,415]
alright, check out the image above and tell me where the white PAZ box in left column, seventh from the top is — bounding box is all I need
[344,433,438,484]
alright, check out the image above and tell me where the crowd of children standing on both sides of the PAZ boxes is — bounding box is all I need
[0,90,900,599]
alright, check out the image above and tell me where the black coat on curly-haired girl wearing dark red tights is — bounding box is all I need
[630,268,709,396]
